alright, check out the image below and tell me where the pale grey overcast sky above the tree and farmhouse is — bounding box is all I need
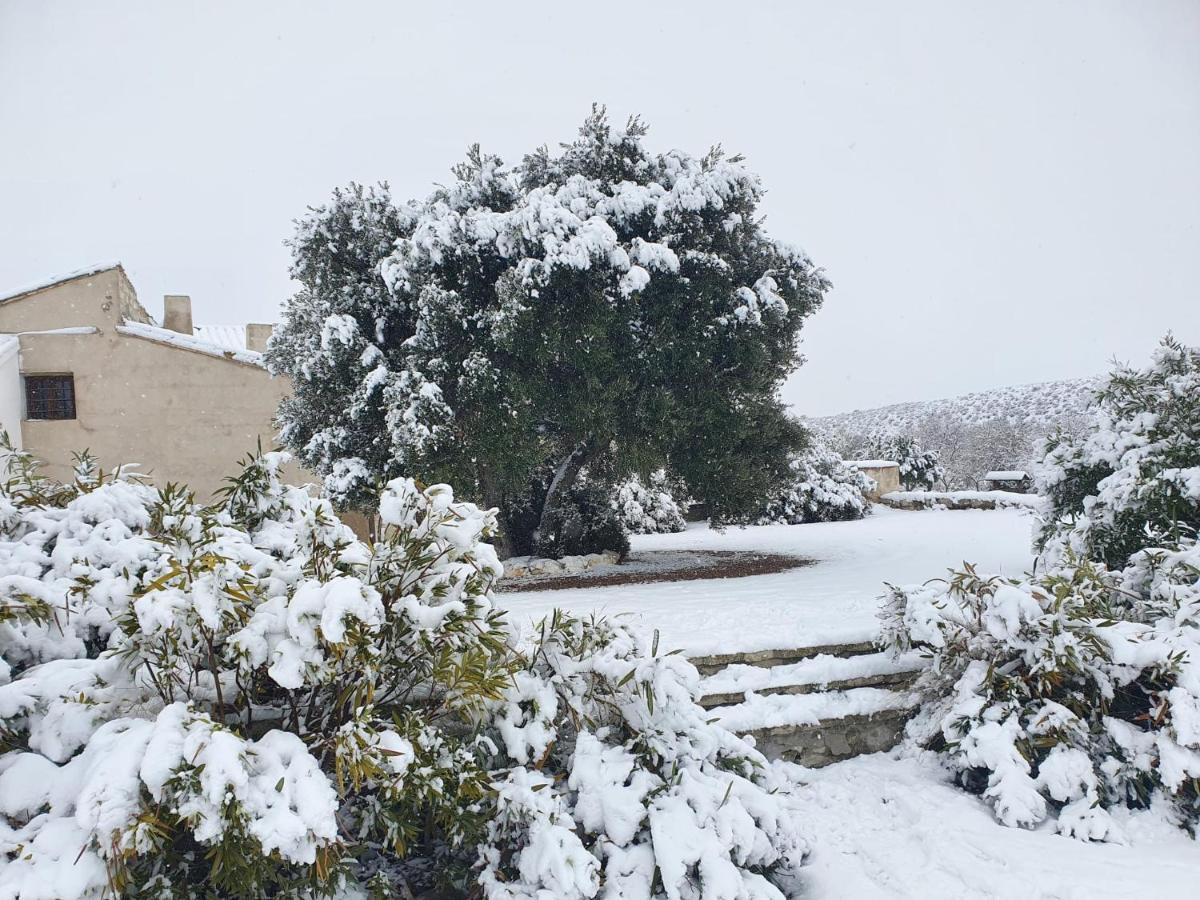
[0,0,1200,414]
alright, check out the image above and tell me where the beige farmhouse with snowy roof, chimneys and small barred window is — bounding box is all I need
[0,263,304,499]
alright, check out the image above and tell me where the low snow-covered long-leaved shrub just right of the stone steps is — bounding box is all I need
[884,541,1200,840]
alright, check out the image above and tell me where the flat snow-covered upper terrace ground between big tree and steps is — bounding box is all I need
[498,506,1032,654]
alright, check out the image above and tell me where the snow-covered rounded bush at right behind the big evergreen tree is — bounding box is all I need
[750,440,875,524]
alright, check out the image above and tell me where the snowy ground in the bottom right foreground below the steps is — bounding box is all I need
[792,754,1200,900]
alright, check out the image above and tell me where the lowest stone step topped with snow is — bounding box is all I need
[712,686,916,767]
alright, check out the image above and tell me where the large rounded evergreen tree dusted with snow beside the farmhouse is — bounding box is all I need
[269,109,827,548]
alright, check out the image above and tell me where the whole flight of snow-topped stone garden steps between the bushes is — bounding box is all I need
[691,642,924,767]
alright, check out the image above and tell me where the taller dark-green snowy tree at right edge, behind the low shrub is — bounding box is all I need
[1038,337,1200,566]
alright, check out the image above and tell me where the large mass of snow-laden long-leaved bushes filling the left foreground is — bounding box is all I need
[0,451,803,900]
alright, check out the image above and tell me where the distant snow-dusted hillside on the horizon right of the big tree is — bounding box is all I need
[812,378,1099,433]
